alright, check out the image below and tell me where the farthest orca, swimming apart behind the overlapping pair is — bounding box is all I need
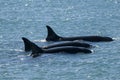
[46,25,113,42]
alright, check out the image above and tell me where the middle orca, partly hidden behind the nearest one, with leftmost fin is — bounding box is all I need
[22,37,93,52]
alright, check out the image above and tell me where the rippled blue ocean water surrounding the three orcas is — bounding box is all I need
[0,0,120,80]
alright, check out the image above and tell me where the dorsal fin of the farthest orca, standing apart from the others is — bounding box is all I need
[46,25,61,41]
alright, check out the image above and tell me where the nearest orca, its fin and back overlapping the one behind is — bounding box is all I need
[22,38,92,57]
